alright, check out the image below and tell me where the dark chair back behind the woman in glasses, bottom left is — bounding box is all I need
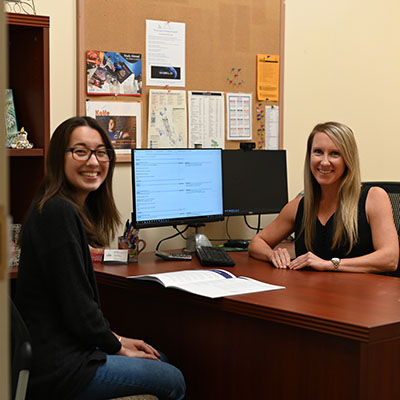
[10,299,32,400]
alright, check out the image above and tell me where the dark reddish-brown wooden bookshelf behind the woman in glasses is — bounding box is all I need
[6,13,50,223]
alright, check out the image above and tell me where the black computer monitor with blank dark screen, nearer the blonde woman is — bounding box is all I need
[222,150,288,216]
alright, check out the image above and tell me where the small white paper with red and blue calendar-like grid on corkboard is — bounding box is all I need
[226,93,252,140]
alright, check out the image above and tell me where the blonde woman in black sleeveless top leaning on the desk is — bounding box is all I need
[249,122,399,272]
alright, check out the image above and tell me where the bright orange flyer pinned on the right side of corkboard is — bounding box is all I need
[257,54,279,101]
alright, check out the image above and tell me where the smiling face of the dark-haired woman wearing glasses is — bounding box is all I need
[64,126,109,204]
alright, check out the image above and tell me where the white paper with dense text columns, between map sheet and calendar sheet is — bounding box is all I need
[188,92,225,148]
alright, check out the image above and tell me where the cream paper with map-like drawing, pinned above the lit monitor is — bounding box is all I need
[147,89,187,149]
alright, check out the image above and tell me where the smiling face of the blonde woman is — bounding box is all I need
[310,132,346,189]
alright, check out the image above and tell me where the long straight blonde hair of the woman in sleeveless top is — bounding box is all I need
[302,122,361,253]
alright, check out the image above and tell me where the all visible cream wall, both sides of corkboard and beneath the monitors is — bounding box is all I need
[35,0,400,250]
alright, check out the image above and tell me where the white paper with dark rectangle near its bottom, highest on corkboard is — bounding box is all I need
[146,20,185,87]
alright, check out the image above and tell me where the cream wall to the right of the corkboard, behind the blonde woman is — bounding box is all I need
[284,0,400,200]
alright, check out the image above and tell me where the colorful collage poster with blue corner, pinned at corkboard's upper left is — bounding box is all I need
[86,50,142,96]
